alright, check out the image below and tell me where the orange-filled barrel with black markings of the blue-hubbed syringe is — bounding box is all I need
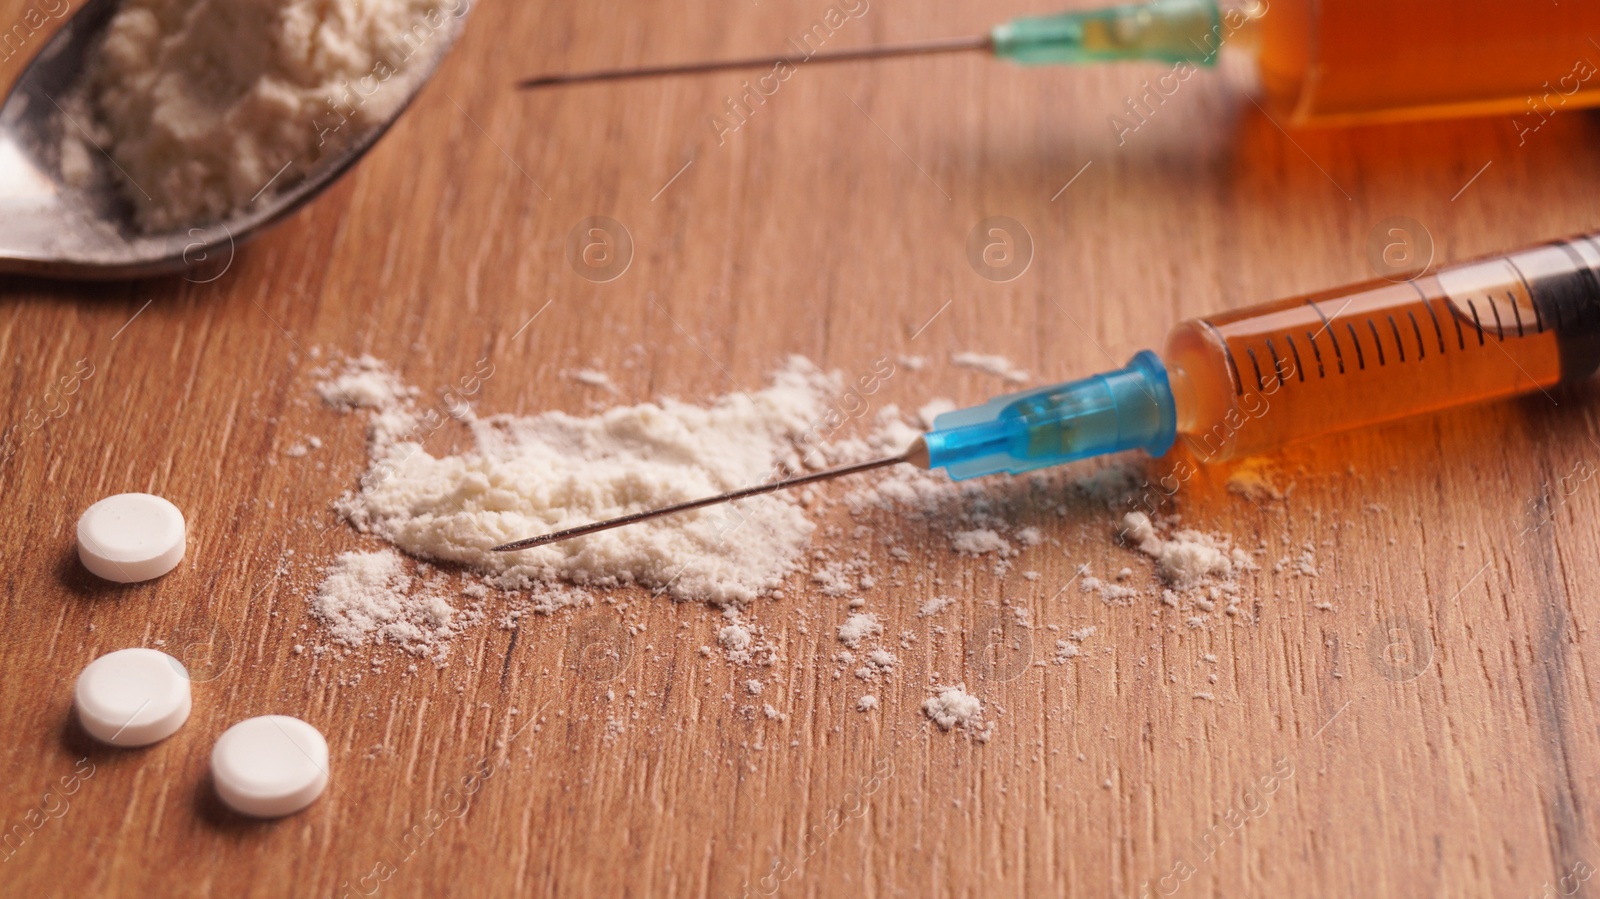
[1163,235,1600,462]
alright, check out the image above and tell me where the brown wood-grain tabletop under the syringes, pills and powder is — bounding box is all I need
[0,0,1600,896]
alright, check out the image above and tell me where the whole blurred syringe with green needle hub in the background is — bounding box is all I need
[522,0,1600,133]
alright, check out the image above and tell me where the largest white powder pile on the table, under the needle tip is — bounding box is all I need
[322,358,876,601]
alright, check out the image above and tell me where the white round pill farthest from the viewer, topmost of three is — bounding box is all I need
[78,493,187,584]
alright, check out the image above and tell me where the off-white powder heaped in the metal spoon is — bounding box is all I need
[62,0,466,230]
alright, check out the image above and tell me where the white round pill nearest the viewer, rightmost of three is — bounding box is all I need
[211,715,328,817]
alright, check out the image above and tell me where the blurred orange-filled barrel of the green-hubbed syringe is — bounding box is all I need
[1251,0,1600,133]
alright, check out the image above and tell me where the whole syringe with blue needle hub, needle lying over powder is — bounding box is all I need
[494,234,1600,552]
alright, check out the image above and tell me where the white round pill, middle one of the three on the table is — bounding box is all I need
[72,649,189,745]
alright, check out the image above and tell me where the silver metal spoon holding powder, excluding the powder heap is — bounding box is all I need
[0,0,467,280]
